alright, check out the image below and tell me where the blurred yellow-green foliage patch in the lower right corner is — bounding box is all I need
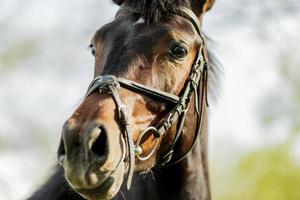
[216,143,300,200]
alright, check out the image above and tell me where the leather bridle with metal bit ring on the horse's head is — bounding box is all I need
[85,8,208,189]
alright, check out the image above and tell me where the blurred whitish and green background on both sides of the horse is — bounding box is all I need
[0,0,300,200]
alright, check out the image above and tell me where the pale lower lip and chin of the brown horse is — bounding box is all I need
[74,164,124,200]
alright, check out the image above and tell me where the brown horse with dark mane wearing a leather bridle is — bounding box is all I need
[29,0,217,200]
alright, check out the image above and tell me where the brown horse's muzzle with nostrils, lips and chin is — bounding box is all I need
[58,122,125,200]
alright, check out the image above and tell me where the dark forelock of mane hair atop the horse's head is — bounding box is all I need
[113,0,190,23]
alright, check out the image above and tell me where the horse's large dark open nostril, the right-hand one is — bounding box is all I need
[89,127,107,157]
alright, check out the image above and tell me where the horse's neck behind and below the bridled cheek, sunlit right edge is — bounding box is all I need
[157,110,210,200]
